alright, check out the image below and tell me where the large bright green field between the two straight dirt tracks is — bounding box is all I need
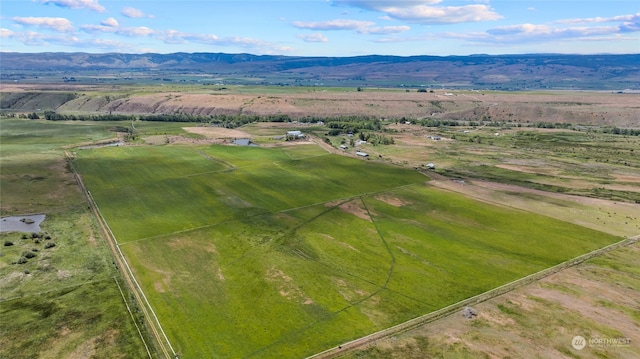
[75,145,619,358]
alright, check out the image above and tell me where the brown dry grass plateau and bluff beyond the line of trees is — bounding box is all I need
[6,84,640,127]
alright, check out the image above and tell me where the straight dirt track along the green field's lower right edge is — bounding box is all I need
[306,235,640,359]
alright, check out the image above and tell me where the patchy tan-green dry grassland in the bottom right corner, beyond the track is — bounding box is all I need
[337,243,640,359]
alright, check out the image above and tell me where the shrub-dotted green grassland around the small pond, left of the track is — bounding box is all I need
[0,118,148,358]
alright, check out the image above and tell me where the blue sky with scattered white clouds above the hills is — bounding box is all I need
[0,0,640,56]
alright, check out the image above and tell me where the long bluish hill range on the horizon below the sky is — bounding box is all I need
[0,52,640,90]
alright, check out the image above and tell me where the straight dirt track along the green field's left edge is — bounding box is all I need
[65,151,178,359]
